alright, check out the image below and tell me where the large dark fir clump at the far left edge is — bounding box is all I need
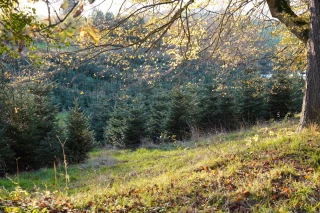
[0,82,59,171]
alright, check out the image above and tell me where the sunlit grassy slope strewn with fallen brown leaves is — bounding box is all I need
[0,117,320,212]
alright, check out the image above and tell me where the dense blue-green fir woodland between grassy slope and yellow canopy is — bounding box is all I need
[0,7,304,175]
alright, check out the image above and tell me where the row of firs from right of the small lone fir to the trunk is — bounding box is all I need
[101,70,304,147]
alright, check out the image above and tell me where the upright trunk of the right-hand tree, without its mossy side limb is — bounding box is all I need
[298,0,320,131]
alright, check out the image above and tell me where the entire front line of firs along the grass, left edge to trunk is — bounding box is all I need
[0,69,304,174]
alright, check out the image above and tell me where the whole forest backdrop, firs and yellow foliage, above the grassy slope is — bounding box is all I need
[0,1,307,174]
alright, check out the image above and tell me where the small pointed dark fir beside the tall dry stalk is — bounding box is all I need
[65,100,94,163]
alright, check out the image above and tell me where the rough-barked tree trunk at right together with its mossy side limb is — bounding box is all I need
[267,0,320,131]
